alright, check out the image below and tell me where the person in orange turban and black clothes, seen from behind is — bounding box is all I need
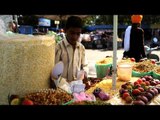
[123,15,146,62]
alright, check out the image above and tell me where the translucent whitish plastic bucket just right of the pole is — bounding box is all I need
[117,63,132,81]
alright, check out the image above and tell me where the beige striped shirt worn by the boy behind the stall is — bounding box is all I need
[55,38,86,82]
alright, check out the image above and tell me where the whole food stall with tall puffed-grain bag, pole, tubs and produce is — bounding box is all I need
[0,16,160,105]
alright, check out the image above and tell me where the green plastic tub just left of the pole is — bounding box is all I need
[95,64,112,78]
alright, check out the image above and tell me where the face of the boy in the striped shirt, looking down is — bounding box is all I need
[65,27,82,42]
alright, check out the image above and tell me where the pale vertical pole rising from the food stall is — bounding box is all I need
[112,15,118,90]
